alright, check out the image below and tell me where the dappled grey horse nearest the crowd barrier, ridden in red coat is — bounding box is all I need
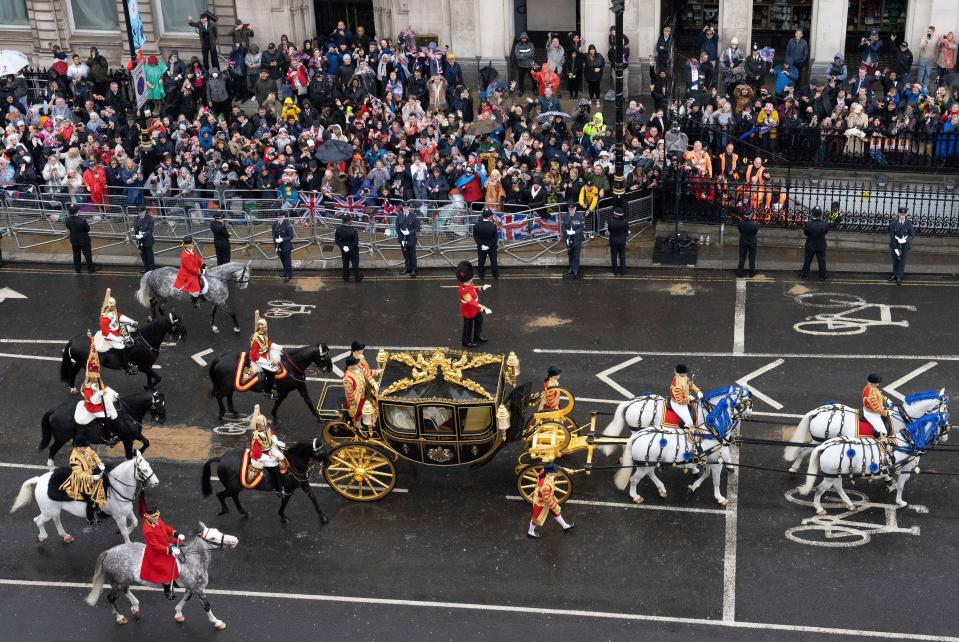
[136,261,250,334]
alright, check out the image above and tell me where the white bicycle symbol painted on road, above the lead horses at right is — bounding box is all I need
[793,292,916,336]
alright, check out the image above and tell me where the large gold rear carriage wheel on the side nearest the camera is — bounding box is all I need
[323,442,396,502]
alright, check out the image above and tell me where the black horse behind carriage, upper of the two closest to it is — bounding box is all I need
[210,343,333,423]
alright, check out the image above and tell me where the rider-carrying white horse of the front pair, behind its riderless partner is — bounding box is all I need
[784,388,949,473]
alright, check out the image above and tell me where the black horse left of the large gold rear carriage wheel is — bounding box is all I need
[201,439,330,524]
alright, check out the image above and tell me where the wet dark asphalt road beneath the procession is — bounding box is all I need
[0,266,959,640]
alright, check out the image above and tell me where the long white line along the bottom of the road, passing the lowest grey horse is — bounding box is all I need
[0,578,959,642]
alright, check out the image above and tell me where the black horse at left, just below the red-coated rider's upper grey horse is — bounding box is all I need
[60,312,186,392]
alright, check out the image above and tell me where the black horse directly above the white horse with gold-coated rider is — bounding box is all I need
[37,390,166,466]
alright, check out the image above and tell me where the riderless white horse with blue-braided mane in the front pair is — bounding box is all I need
[799,413,949,515]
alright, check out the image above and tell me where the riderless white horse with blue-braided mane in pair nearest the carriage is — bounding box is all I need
[613,386,752,506]
